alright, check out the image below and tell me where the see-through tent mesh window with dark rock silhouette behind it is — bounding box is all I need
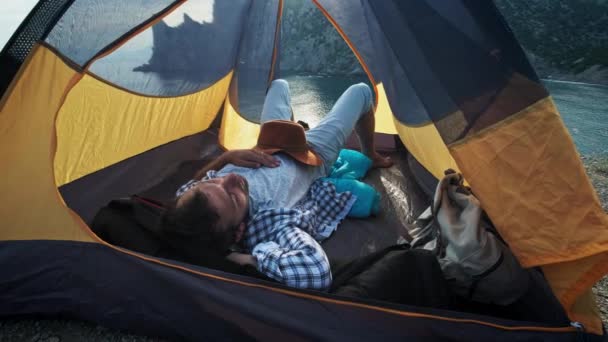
[86,0,251,97]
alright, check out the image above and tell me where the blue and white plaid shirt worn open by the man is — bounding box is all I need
[176,171,356,291]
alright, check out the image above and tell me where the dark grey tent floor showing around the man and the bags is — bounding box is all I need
[54,130,567,324]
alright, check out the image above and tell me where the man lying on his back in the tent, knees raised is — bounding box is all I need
[161,80,392,290]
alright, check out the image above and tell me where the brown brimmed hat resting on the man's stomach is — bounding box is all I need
[254,120,323,166]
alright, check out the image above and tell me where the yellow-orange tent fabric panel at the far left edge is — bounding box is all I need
[0,45,93,241]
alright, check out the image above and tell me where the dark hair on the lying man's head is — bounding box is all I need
[161,192,236,257]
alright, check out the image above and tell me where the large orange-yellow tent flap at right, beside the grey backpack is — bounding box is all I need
[449,98,608,332]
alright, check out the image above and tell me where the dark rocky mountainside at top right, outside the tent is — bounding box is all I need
[494,0,608,85]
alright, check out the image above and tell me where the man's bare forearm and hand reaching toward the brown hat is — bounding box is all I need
[194,149,280,179]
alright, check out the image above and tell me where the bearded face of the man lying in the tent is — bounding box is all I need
[177,173,249,242]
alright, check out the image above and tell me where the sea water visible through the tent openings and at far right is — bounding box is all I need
[86,58,608,156]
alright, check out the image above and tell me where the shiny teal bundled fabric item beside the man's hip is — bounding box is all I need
[323,149,380,218]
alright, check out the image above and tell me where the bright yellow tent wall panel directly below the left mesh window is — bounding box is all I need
[55,72,232,185]
